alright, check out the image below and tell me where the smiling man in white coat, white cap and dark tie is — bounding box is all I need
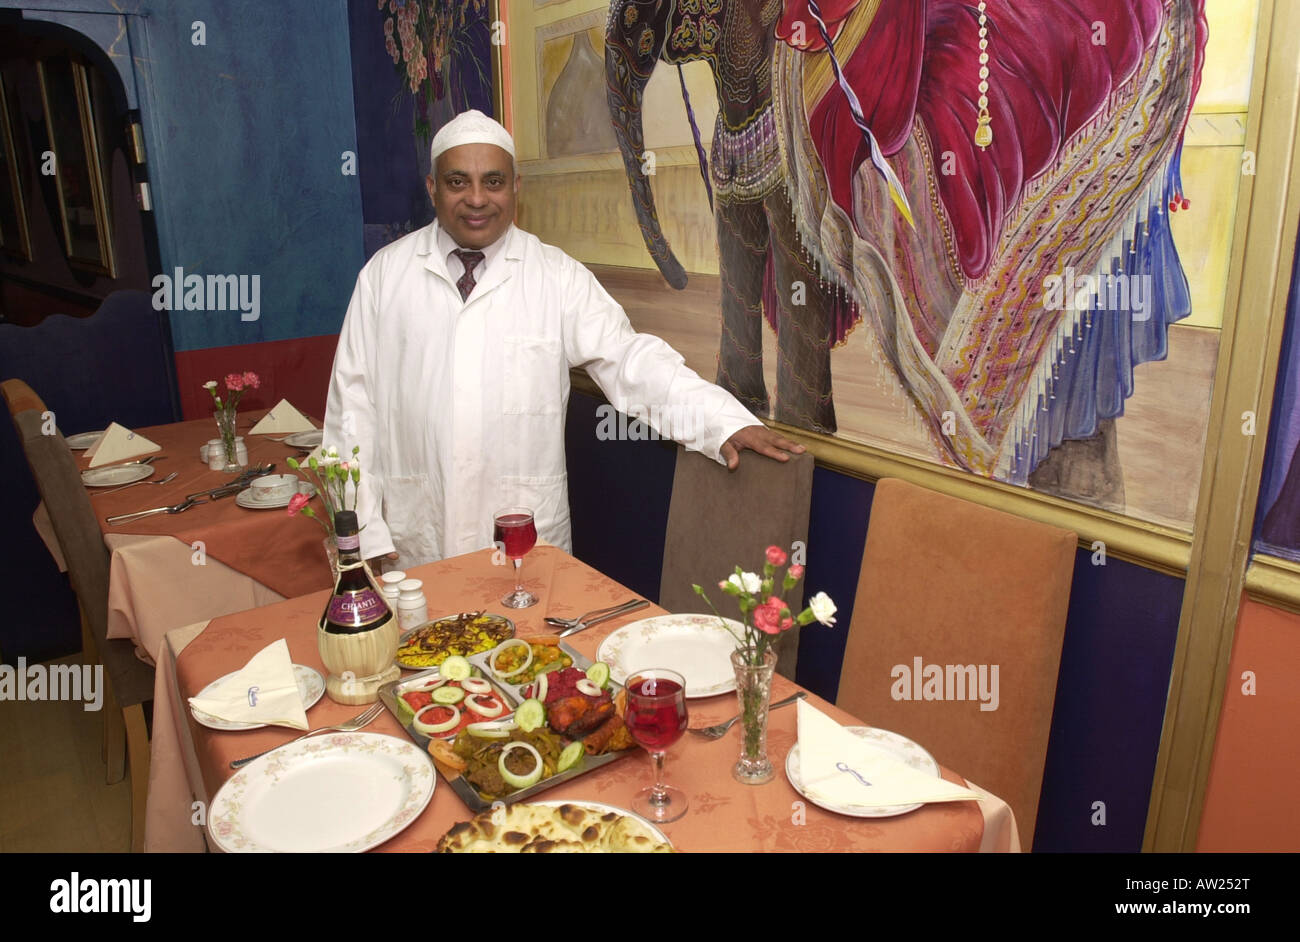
[325,112,803,566]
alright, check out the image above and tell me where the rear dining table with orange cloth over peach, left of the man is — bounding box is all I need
[34,409,332,663]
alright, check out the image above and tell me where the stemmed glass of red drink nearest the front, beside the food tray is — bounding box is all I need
[623,668,686,824]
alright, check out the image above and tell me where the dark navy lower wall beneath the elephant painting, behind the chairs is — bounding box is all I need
[566,394,1183,852]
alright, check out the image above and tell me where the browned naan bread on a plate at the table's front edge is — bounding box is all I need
[438,804,672,854]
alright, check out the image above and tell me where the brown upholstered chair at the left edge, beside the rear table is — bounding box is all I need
[0,379,153,851]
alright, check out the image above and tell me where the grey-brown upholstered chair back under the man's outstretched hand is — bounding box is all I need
[659,446,814,680]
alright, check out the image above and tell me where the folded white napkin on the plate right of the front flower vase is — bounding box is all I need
[798,700,979,808]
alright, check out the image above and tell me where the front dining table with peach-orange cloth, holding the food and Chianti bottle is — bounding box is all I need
[146,544,1021,852]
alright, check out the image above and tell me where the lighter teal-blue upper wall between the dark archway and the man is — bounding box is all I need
[0,0,361,352]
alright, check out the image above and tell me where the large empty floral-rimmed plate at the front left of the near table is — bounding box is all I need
[208,733,437,854]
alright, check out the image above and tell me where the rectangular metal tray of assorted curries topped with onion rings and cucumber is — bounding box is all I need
[380,644,636,812]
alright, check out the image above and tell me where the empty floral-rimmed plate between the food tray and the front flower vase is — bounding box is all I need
[595,615,744,699]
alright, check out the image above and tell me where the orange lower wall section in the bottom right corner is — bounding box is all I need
[1196,599,1300,852]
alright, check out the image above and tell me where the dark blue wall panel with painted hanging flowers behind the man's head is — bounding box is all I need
[348,0,493,256]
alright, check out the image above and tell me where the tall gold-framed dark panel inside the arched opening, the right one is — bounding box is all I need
[36,58,117,278]
